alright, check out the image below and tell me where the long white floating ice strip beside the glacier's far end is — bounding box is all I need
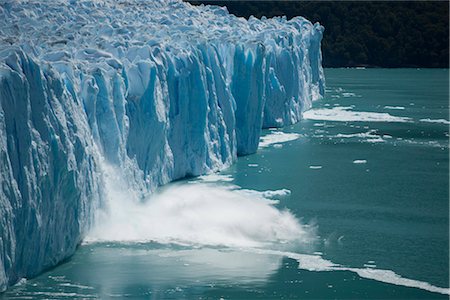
[303,107,412,123]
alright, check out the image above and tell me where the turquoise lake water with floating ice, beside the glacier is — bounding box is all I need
[0,69,449,299]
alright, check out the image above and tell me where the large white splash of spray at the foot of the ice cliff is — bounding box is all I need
[85,166,315,247]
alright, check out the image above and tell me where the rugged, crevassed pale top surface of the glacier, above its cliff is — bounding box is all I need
[0,0,312,71]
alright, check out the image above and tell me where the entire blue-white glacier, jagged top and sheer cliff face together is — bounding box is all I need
[0,0,324,291]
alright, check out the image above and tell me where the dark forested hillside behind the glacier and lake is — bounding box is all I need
[189,1,449,68]
